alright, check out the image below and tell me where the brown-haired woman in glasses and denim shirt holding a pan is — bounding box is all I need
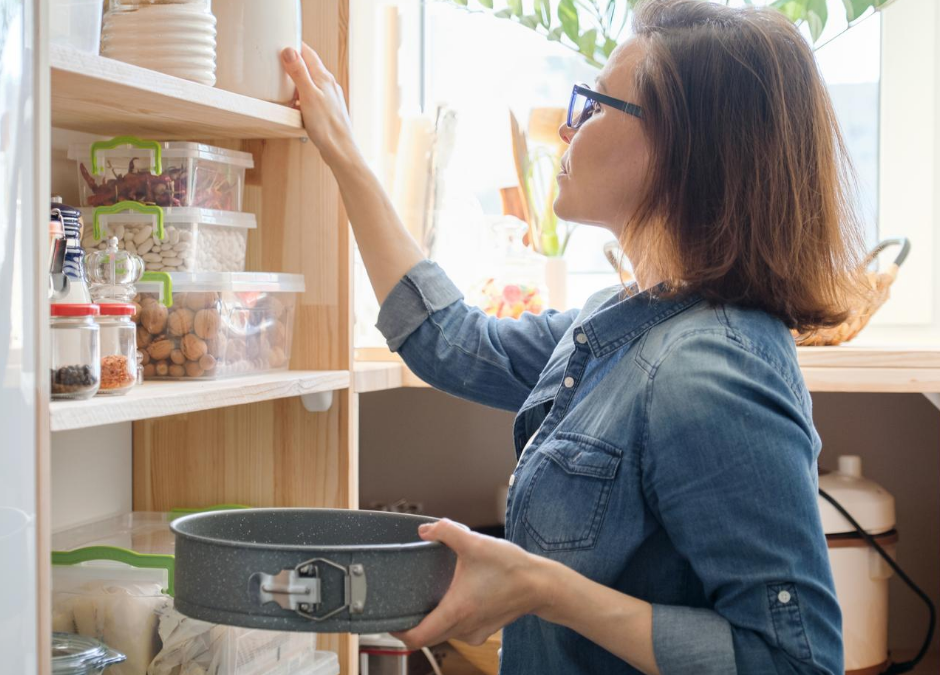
[284,0,857,675]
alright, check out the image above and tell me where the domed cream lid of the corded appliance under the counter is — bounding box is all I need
[819,455,895,534]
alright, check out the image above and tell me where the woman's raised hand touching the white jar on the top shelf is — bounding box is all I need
[281,44,359,167]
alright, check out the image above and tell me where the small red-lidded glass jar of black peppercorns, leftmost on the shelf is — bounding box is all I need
[49,304,101,399]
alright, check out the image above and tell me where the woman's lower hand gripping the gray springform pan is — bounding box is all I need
[395,519,550,649]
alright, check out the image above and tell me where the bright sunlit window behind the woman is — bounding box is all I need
[352,0,940,344]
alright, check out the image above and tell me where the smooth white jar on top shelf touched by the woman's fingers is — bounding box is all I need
[212,0,302,103]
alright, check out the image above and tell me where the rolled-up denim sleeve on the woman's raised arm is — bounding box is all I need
[376,260,578,412]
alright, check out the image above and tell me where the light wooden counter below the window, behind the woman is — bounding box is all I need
[355,345,940,393]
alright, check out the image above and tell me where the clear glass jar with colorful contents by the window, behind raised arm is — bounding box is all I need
[471,217,547,319]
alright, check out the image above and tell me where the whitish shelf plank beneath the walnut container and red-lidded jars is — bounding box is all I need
[49,370,350,431]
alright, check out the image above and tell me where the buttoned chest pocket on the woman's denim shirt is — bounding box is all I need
[522,433,622,551]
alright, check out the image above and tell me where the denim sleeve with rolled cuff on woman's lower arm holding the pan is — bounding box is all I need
[641,333,843,675]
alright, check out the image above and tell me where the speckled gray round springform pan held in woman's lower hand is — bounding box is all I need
[171,509,457,633]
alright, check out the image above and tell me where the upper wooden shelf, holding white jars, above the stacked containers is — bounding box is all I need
[49,46,306,139]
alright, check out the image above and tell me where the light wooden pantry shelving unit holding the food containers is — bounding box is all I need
[39,0,359,675]
